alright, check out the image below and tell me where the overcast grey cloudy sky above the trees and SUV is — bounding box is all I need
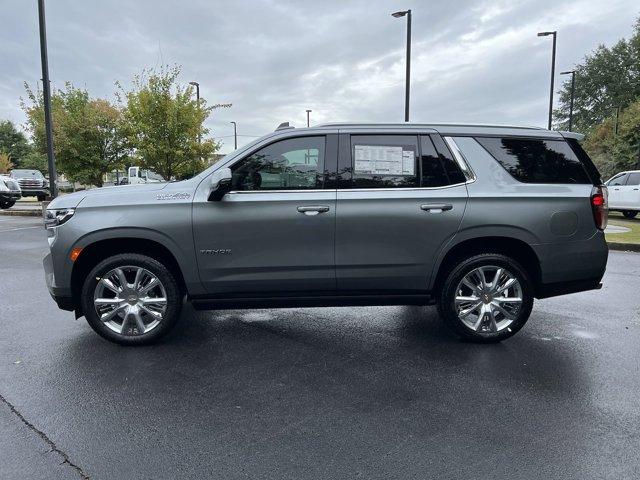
[0,0,640,153]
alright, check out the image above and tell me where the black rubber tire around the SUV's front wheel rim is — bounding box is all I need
[81,253,183,345]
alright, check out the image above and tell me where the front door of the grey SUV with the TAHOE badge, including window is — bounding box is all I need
[193,135,337,296]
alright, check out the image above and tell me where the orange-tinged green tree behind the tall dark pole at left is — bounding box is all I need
[23,83,131,187]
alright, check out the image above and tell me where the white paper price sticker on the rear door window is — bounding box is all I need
[354,145,416,176]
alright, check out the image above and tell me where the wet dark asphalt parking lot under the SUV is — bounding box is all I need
[0,217,640,479]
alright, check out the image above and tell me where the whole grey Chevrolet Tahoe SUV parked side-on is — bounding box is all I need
[44,124,608,345]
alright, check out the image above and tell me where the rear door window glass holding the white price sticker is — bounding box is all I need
[351,135,420,188]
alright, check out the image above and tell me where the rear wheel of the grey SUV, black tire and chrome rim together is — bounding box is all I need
[437,254,533,343]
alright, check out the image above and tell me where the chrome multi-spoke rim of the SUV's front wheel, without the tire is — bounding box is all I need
[93,266,167,336]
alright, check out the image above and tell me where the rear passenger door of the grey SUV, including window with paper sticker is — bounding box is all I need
[336,134,467,295]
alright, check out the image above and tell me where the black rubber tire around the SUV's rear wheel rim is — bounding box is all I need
[437,253,534,343]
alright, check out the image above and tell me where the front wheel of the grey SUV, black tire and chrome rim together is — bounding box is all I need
[82,253,182,345]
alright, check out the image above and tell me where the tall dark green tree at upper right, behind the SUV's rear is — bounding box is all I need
[554,18,640,133]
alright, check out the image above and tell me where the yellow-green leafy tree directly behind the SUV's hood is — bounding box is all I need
[119,66,219,180]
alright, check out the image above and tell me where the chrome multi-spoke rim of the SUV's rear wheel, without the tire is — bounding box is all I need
[455,266,522,334]
